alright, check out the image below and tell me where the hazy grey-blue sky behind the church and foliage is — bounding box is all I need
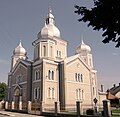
[0,0,120,89]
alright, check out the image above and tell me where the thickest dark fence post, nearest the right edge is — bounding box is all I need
[103,100,111,117]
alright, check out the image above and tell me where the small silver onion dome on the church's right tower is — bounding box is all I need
[76,40,91,54]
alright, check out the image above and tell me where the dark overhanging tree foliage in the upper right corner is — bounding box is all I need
[75,0,120,47]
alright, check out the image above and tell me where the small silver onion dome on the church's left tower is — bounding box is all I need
[14,41,27,56]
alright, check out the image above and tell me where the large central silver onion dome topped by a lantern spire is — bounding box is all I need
[38,9,60,38]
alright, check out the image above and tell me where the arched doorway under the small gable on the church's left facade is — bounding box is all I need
[14,88,20,110]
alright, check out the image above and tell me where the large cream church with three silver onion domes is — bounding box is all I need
[6,10,99,113]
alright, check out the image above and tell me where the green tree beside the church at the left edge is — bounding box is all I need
[0,83,7,101]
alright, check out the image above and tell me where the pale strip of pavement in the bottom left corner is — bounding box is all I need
[0,110,45,117]
